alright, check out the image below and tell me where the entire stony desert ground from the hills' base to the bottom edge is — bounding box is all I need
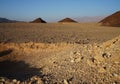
[0,23,120,84]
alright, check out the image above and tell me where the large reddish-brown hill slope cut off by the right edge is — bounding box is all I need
[100,11,120,27]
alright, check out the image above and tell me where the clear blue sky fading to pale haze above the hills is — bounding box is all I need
[0,0,120,21]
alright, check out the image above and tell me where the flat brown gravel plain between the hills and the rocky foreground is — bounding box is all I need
[0,23,120,44]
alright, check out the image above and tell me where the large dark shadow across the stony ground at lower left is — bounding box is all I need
[0,60,43,81]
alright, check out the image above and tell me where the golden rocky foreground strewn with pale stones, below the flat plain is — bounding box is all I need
[0,22,120,84]
